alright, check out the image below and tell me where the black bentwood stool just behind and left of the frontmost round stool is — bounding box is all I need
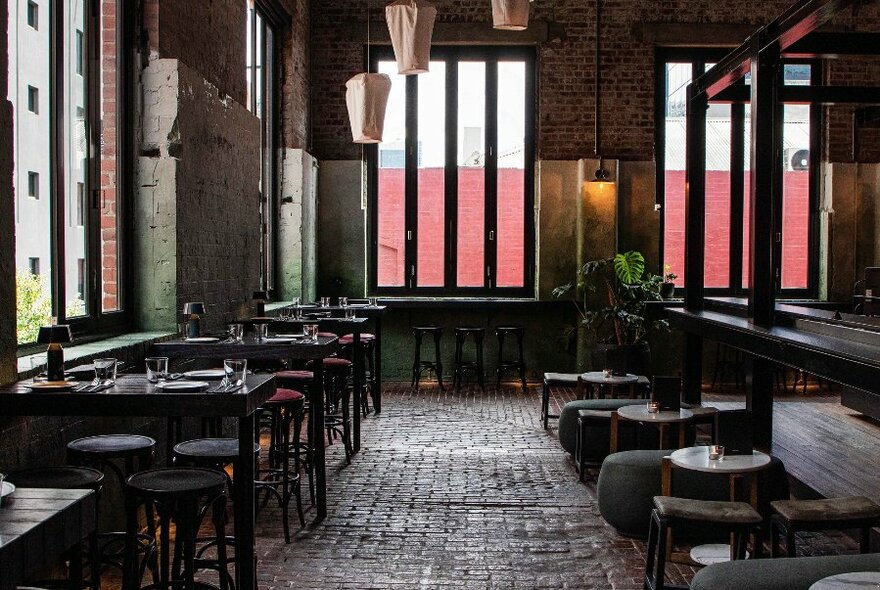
[67,434,158,580]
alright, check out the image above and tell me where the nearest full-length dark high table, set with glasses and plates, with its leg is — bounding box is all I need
[0,376,278,590]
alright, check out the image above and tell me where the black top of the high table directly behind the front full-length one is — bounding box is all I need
[153,336,338,360]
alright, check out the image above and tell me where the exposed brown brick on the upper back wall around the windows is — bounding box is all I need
[312,0,880,161]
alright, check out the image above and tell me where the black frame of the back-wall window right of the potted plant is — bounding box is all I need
[654,47,823,299]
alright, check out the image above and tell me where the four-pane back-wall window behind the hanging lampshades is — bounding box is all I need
[367,47,535,295]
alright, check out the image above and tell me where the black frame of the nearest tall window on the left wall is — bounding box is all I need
[18,0,137,355]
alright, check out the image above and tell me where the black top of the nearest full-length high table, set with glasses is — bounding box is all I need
[0,375,275,417]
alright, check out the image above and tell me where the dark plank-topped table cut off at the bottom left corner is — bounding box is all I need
[0,488,97,590]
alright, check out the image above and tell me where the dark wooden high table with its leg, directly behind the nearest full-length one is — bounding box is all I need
[153,338,340,520]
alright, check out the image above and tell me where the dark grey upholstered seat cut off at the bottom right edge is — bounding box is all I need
[690,553,880,590]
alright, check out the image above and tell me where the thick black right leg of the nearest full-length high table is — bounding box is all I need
[233,414,257,590]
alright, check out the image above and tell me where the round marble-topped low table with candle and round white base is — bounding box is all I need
[663,447,770,565]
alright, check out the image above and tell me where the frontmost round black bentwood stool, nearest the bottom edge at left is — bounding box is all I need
[122,468,229,590]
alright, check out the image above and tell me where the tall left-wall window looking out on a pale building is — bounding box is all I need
[7,0,125,344]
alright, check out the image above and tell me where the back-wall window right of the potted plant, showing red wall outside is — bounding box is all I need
[656,51,821,296]
